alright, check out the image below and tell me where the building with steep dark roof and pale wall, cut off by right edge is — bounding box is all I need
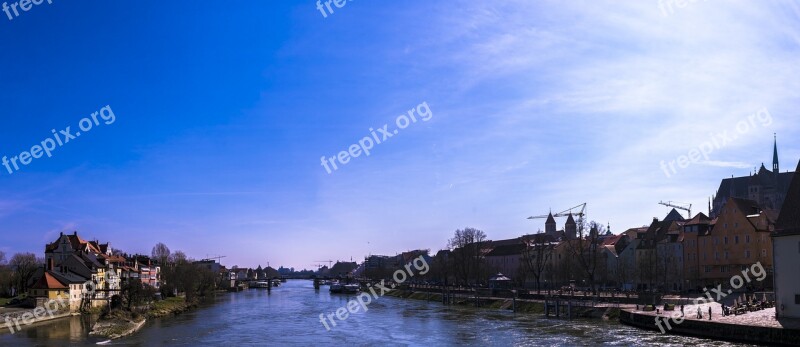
[772,160,800,318]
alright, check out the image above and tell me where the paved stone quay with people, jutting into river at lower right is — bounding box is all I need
[619,308,800,346]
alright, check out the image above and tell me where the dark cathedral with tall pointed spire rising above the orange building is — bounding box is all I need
[710,138,794,218]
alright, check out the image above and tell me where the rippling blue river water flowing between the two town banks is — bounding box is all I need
[0,280,752,346]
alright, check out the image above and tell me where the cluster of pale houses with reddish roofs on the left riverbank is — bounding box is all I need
[28,232,161,312]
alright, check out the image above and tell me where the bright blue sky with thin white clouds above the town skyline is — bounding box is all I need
[0,0,800,269]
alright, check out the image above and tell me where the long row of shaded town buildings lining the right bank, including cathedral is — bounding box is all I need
[424,144,800,303]
